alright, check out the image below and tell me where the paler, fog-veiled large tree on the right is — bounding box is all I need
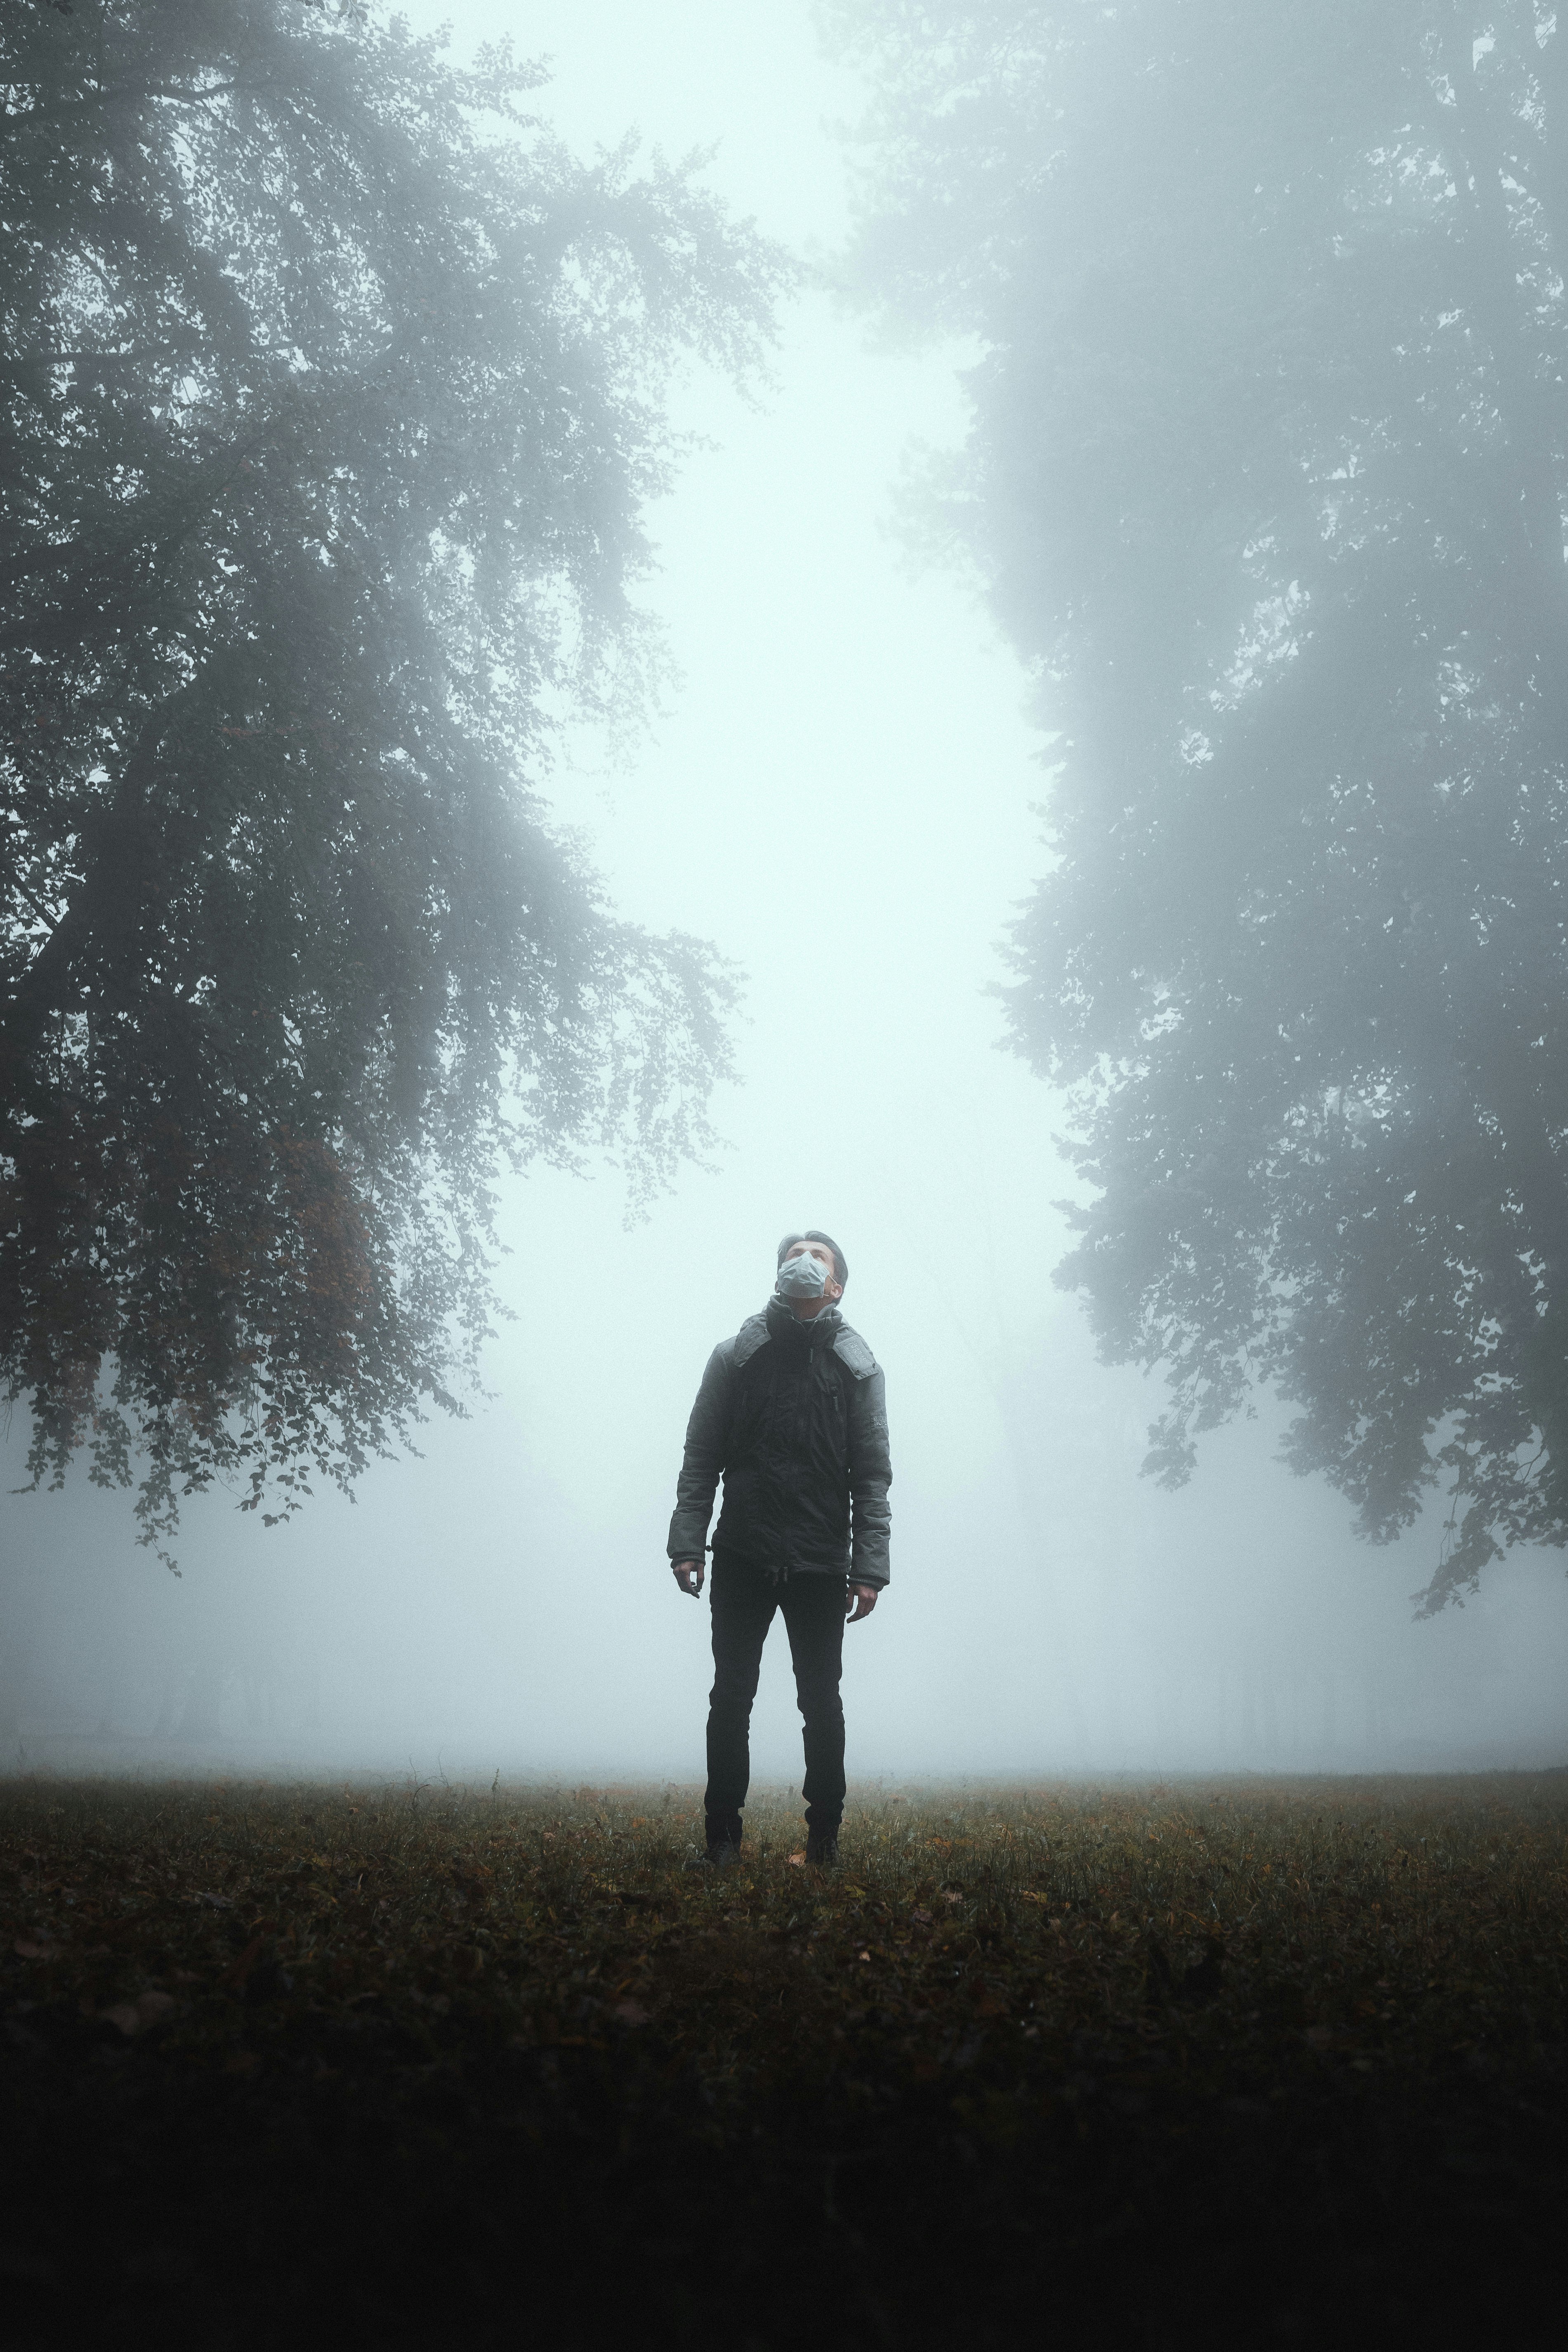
[830,0,1568,1607]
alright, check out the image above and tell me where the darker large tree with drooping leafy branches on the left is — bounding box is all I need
[0,0,780,1536]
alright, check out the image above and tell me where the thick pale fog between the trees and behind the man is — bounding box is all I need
[2,0,1568,1804]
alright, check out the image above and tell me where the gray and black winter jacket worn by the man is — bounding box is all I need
[670,1298,893,1585]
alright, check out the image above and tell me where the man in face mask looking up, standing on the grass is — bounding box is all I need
[670,1232,893,1865]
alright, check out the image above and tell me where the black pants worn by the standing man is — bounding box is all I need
[707,1552,849,1839]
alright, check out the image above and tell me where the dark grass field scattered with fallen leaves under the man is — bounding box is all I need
[0,1774,1568,2347]
